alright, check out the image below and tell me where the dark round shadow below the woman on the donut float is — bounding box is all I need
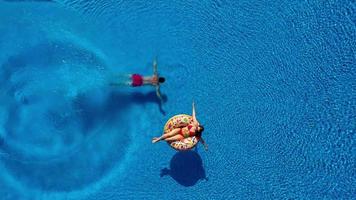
[160,151,208,187]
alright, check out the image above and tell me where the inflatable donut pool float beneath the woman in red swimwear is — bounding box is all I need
[163,114,200,151]
